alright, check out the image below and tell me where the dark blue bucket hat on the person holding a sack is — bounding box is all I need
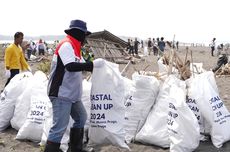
[65,20,91,35]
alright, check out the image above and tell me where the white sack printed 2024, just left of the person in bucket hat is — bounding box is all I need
[16,71,50,141]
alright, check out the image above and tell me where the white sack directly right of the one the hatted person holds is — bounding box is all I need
[125,73,159,143]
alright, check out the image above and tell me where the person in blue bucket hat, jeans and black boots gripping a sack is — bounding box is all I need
[45,20,104,152]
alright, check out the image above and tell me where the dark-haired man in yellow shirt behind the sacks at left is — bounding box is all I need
[4,32,31,86]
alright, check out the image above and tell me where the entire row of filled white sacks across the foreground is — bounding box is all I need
[0,58,230,152]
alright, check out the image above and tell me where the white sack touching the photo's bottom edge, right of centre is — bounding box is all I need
[167,75,200,152]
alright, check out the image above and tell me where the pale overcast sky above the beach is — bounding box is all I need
[0,0,230,42]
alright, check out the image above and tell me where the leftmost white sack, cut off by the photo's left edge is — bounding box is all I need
[0,72,33,131]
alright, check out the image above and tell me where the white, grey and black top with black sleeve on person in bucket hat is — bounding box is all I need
[48,41,93,103]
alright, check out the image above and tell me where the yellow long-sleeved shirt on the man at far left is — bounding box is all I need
[4,43,29,70]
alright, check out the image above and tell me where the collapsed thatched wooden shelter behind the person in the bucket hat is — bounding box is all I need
[86,30,128,63]
